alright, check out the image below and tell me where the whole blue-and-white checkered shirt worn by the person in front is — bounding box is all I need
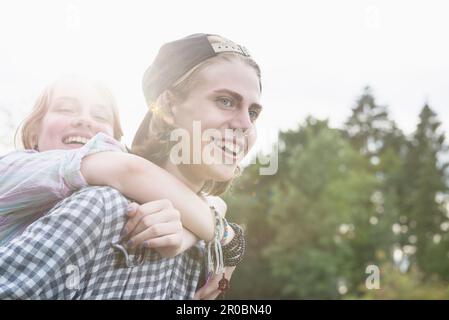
[0,187,205,299]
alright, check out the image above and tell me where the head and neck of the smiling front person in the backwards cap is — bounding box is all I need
[132,34,262,298]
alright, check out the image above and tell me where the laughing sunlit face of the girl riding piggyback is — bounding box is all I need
[35,79,114,151]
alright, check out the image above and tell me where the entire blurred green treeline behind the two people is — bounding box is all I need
[226,88,449,299]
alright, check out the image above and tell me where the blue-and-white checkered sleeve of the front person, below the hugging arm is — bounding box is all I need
[0,187,127,299]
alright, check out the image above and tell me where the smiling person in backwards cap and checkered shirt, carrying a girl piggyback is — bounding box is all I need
[0,35,261,299]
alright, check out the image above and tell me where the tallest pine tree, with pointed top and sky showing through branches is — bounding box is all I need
[344,87,407,272]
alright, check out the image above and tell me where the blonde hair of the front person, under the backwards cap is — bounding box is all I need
[132,36,261,196]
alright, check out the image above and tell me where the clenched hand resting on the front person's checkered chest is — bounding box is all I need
[123,199,183,257]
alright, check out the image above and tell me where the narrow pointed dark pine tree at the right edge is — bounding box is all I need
[403,104,449,279]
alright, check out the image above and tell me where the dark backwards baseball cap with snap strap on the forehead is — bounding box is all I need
[142,33,250,105]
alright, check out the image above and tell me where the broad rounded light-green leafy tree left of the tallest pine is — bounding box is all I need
[264,118,376,298]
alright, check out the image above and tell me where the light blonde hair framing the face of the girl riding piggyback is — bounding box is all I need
[14,76,123,149]
